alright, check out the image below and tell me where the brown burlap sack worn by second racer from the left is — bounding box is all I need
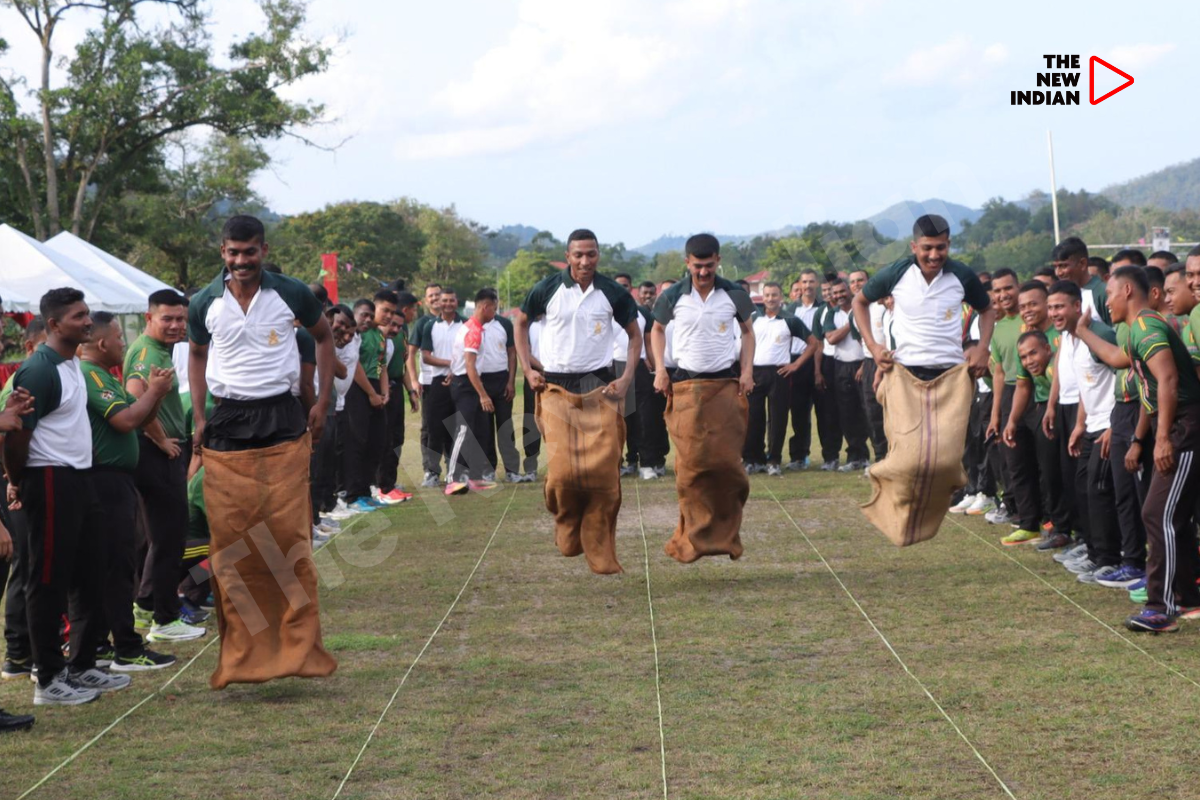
[536,384,625,575]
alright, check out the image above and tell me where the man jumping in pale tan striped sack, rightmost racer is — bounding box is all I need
[853,215,996,547]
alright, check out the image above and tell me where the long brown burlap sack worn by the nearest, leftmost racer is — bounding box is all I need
[204,434,337,688]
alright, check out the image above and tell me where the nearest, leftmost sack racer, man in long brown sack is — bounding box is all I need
[188,216,337,688]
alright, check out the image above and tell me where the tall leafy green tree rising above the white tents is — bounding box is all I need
[0,0,329,239]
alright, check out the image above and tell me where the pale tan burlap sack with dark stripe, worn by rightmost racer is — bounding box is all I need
[863,363,974,547]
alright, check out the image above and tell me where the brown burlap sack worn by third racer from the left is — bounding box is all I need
[664,379,750,564]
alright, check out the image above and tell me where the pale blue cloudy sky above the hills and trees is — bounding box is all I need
[0,0,1200,247]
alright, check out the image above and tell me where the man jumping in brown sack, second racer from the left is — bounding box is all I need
[515,229,642,575]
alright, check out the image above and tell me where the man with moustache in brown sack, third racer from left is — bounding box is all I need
[650,234,755,564]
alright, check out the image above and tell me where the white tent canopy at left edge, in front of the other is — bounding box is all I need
[0,224,146,314]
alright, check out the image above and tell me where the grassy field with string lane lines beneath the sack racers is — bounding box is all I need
[0,395,1200,800]
